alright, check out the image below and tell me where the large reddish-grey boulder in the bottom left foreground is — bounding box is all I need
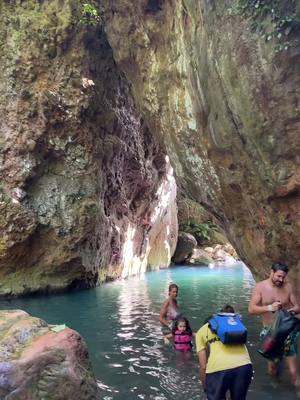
[0,310,100,400]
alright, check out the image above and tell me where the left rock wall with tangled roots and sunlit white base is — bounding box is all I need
[0,0,177,295]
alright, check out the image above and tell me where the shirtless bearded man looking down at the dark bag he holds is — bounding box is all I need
[248,263,300,388]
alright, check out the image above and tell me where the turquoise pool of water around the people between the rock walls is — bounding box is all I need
[0,263,297,400]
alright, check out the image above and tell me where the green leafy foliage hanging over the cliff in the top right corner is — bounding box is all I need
[228,0,300,51]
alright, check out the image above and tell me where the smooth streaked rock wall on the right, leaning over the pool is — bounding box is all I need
[105,0,300,286]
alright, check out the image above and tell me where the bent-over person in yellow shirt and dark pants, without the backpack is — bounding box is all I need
[196,305,253,400]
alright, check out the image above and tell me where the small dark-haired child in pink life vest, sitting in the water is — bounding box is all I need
[164,317,194,352]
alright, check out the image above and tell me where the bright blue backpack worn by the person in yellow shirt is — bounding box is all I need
[208,313,247,344]
